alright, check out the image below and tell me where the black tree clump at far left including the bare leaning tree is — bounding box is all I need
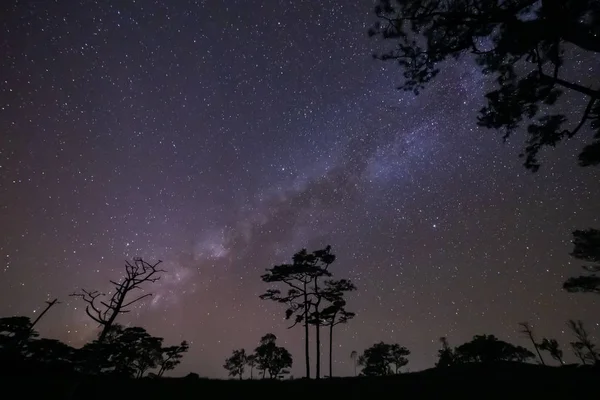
[0,258,189,378]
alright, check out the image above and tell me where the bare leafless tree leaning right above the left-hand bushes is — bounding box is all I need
[71,258,164,342]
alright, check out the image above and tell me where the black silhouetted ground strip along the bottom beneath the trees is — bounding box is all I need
[0,364,600,400]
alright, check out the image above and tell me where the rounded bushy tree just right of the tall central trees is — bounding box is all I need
[358,342,410,376]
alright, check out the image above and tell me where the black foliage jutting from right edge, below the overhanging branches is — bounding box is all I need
[563,229,600,294]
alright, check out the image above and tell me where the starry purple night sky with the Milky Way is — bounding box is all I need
[0,0,600,377]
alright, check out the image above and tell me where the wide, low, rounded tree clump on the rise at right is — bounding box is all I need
[455,335,535,363]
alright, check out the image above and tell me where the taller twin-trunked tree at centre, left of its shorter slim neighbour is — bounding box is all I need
[260,246,335,378]
